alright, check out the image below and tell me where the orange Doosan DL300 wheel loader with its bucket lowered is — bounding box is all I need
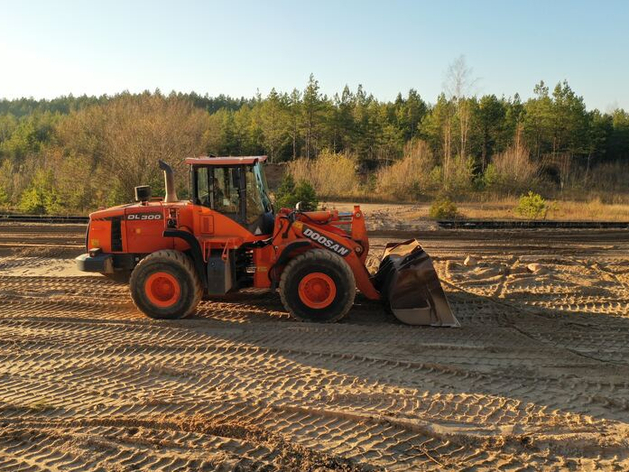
[76,156,459,326]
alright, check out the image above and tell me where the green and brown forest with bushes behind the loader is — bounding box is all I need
[0,66,629,214]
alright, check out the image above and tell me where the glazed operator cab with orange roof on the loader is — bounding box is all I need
[186,156,274,235]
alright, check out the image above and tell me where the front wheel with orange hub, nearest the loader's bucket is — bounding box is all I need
[279,249,356,323]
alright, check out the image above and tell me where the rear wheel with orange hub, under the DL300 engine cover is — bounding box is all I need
[129,250,203,319]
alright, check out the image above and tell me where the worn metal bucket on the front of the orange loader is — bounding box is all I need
[373,239,460,327]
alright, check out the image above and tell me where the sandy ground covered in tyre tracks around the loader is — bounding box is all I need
[0,225,629,471]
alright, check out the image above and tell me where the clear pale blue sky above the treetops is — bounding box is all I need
[0,0,629,110]
